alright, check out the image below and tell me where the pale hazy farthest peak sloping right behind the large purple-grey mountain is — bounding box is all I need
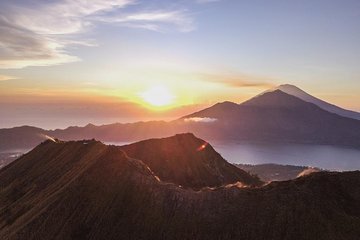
[276,84,360,120]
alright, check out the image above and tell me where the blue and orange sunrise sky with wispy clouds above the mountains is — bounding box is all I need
[0,0,360,128]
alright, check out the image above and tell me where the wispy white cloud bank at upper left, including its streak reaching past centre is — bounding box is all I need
[0,0,194,69]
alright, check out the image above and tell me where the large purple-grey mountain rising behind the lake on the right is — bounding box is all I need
[185,90,360,147]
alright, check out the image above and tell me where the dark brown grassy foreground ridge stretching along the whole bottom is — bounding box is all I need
[0,136,360,240]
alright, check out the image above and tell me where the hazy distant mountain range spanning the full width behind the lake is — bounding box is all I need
[0,85,360,155]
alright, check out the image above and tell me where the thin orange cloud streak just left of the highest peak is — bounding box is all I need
[200,74,275,88]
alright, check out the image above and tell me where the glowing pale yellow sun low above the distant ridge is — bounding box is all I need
[140,85,175,107]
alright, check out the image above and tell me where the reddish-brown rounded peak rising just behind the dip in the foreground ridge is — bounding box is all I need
[121,133,261,188]
